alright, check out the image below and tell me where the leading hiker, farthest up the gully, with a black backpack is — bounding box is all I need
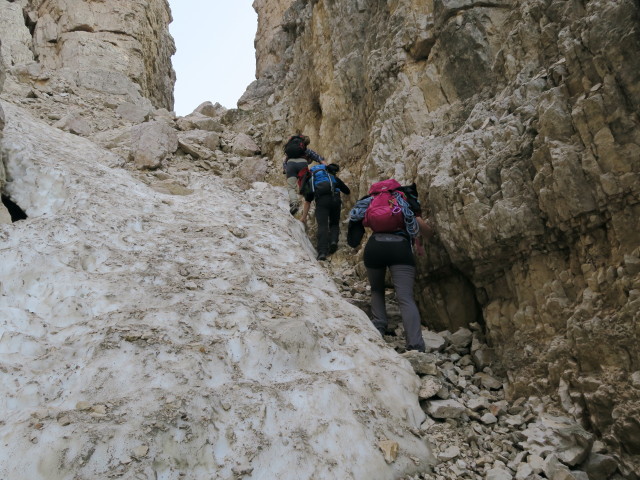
[282,135,326,215]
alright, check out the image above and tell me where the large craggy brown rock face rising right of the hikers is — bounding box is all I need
[249,0,640,478]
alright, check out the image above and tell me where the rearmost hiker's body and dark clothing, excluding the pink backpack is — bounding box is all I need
[347,180,433,352]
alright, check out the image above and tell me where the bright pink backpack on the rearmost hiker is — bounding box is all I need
[362,178,405,233]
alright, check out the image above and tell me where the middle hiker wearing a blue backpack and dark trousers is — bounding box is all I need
[300,163,351,260]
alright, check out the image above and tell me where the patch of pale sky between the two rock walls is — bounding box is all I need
[169,0,258,116]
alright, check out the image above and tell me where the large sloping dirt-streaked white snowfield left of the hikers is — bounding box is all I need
[0,103,433,480]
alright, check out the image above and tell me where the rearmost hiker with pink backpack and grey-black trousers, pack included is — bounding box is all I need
[347,179,433,352]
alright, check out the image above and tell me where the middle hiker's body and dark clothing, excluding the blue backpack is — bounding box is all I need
[300,163,351,260]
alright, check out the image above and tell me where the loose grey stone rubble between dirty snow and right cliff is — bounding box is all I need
[323,262,623,480]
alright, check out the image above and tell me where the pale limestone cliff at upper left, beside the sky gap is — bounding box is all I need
[0,0,175,110]
